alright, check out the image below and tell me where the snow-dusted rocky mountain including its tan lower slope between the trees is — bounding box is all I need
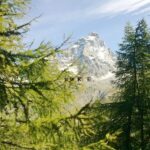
[58,33,116,103]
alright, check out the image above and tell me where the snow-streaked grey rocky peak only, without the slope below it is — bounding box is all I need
[60,32,115,78]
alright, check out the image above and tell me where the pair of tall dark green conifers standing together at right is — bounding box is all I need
[116,20,150,150]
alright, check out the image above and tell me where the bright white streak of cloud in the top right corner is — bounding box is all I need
[90,0,150,15]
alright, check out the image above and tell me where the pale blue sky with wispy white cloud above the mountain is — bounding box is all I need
[26,0,150,51]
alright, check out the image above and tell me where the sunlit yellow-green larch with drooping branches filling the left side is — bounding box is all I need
[0,0,78,150]
